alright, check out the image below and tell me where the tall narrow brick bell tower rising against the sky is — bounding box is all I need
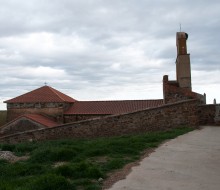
[176,32,192,90]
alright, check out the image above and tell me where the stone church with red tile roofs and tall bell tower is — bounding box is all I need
[0,32,206,136]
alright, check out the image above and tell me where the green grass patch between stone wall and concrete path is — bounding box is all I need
[0,127,193,190]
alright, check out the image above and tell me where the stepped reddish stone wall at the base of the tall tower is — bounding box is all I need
[163,75,206,104]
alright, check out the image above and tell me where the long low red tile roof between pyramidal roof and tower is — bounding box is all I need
[65,99,163,115]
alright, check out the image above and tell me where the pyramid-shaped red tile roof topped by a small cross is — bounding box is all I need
[4,86,76,103]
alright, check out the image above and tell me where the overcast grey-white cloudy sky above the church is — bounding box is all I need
[0,0,220,109]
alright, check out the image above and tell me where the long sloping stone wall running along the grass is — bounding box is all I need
[0,100,199,143]
